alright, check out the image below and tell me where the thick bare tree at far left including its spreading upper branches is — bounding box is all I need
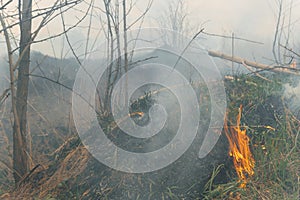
[0,0,82,186]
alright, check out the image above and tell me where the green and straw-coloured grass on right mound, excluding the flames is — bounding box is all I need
[203,74,300,200]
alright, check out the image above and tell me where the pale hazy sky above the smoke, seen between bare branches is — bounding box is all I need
[0,0,300,62]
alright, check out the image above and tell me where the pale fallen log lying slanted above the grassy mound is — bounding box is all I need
[208,51,300,76]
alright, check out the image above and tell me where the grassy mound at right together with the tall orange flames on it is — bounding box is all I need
[203,75,300,200]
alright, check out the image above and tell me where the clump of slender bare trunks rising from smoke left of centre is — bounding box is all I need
[99,0,152,113]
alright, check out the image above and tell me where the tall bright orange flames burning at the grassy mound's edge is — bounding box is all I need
[224,105,255,188]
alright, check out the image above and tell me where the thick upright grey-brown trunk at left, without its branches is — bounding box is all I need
[13,0,32,184]
